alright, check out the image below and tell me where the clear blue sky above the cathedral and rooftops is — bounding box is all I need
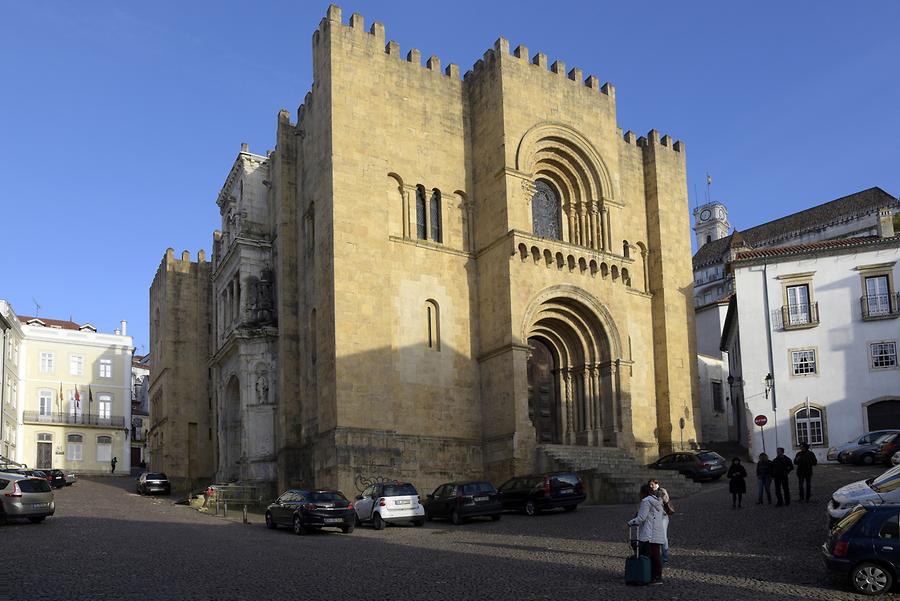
[0,0,900,352]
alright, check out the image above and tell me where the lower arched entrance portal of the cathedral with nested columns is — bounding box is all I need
[524,286,630,445]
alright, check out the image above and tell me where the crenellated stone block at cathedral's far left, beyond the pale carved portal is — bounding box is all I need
[148,248,215,490]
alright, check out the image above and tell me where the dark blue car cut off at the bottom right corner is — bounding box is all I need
[822,503,900,595]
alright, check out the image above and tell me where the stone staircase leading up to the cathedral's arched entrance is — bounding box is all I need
[537,445,700,503]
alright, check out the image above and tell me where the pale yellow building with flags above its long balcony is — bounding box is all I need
[16,316,134,474]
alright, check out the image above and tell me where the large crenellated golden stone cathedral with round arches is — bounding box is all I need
[151,6,699,492]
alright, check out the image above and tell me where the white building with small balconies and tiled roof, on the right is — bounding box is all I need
[722,218,900,461]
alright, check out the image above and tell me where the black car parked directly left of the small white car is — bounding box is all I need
[266,489,356,534]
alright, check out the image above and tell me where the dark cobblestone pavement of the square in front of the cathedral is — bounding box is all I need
[0,466,884,601]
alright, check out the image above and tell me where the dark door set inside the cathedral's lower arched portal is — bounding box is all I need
[528,338,562,444]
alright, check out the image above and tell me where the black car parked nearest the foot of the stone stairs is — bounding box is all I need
[500,472,587,515]
